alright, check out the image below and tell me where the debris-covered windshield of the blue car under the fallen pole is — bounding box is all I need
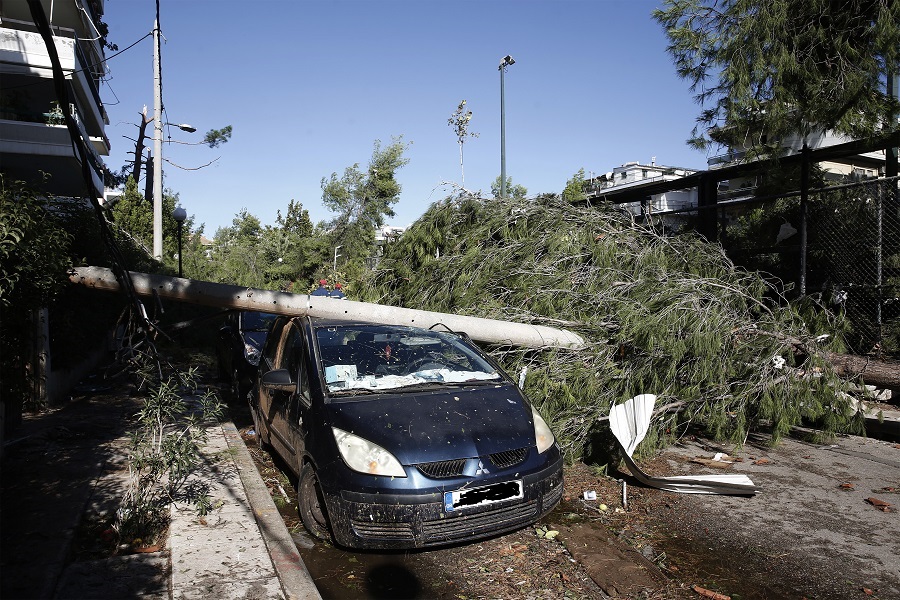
[316,325,502,395]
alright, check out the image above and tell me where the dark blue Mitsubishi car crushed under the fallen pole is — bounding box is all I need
[250,317,563,549]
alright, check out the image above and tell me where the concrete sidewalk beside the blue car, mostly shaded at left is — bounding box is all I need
[0,393,321,600]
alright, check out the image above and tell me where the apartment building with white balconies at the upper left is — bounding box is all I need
[0,0,109,197]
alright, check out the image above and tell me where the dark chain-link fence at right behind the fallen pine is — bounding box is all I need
[654,178,900,356]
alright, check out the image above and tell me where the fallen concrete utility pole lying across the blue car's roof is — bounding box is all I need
[69,267,584,348]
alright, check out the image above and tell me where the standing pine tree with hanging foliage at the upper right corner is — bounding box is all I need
[653,0,900,149]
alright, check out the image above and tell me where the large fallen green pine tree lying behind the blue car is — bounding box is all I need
[361,195,862,458]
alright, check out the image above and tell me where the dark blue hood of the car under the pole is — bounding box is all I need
[328,385,535,465]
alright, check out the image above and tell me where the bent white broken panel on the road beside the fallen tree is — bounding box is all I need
[609,394,759,495]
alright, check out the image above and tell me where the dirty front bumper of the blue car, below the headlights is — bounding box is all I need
[325,452,563,549]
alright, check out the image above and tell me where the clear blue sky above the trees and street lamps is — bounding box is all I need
[101,0,706,237]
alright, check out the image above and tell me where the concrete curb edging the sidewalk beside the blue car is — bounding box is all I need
[222,421,322,600]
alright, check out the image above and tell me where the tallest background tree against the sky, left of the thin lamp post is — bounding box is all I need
[322,136,409,279]
